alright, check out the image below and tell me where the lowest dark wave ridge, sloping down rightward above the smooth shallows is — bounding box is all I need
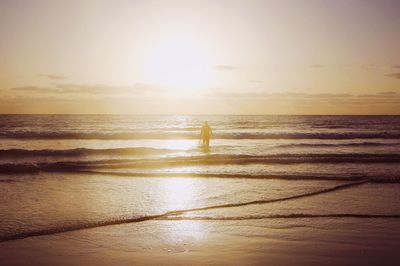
[0,162,400,183]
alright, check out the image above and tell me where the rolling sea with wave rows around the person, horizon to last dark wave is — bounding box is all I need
[0,115,400,182]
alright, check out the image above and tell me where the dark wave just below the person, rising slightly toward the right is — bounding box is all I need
[0,153,400,173]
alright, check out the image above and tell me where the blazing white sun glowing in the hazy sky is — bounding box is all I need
[143,38,210,92]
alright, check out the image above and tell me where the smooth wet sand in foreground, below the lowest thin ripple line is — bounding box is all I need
[0,218,400,265]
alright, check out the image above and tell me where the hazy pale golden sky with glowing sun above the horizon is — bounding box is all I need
[0,0,400,114]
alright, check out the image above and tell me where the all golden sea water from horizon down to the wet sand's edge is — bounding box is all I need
[0,115,400,250]
